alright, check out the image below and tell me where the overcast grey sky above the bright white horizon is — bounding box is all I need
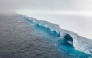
[0,0,92,12]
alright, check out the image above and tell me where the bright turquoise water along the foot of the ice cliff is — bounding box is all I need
[25,19,90,58]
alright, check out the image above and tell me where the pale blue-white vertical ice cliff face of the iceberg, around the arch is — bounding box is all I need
[19,15,92,54]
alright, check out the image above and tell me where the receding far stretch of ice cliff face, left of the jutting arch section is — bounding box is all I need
[22,16,60,37]
